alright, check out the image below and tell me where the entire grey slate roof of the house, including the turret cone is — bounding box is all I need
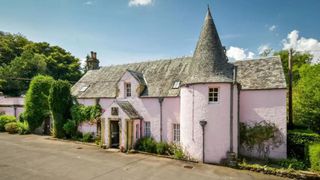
[71,9,286,98]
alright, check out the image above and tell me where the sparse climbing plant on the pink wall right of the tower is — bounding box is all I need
[240,121,283,158]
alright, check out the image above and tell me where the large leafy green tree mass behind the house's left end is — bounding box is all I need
[0,32,82,96]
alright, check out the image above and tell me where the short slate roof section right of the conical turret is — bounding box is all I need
[234,56,286,89]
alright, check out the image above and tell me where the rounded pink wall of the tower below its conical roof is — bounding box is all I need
[180,83,237,163]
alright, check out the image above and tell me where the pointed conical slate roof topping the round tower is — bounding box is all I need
[186,8,233,83]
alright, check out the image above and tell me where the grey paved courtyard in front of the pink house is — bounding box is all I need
[0,133,281,180]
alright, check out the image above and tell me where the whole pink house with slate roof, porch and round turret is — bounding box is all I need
[72,10,286,163]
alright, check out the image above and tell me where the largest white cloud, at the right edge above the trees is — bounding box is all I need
[282,30,320,62]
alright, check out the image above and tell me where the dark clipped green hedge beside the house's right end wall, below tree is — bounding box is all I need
[288,130,320,160]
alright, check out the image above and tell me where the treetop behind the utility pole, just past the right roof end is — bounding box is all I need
[274,50,312,85]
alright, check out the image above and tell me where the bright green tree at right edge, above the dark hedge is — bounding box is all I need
[293,64,320,132]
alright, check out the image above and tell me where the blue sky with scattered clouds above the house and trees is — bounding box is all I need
[0,0,320,65]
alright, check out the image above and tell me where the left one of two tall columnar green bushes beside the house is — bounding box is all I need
[23,75,54,131]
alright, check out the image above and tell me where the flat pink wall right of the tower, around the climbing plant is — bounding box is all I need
[240,89,287,159]
